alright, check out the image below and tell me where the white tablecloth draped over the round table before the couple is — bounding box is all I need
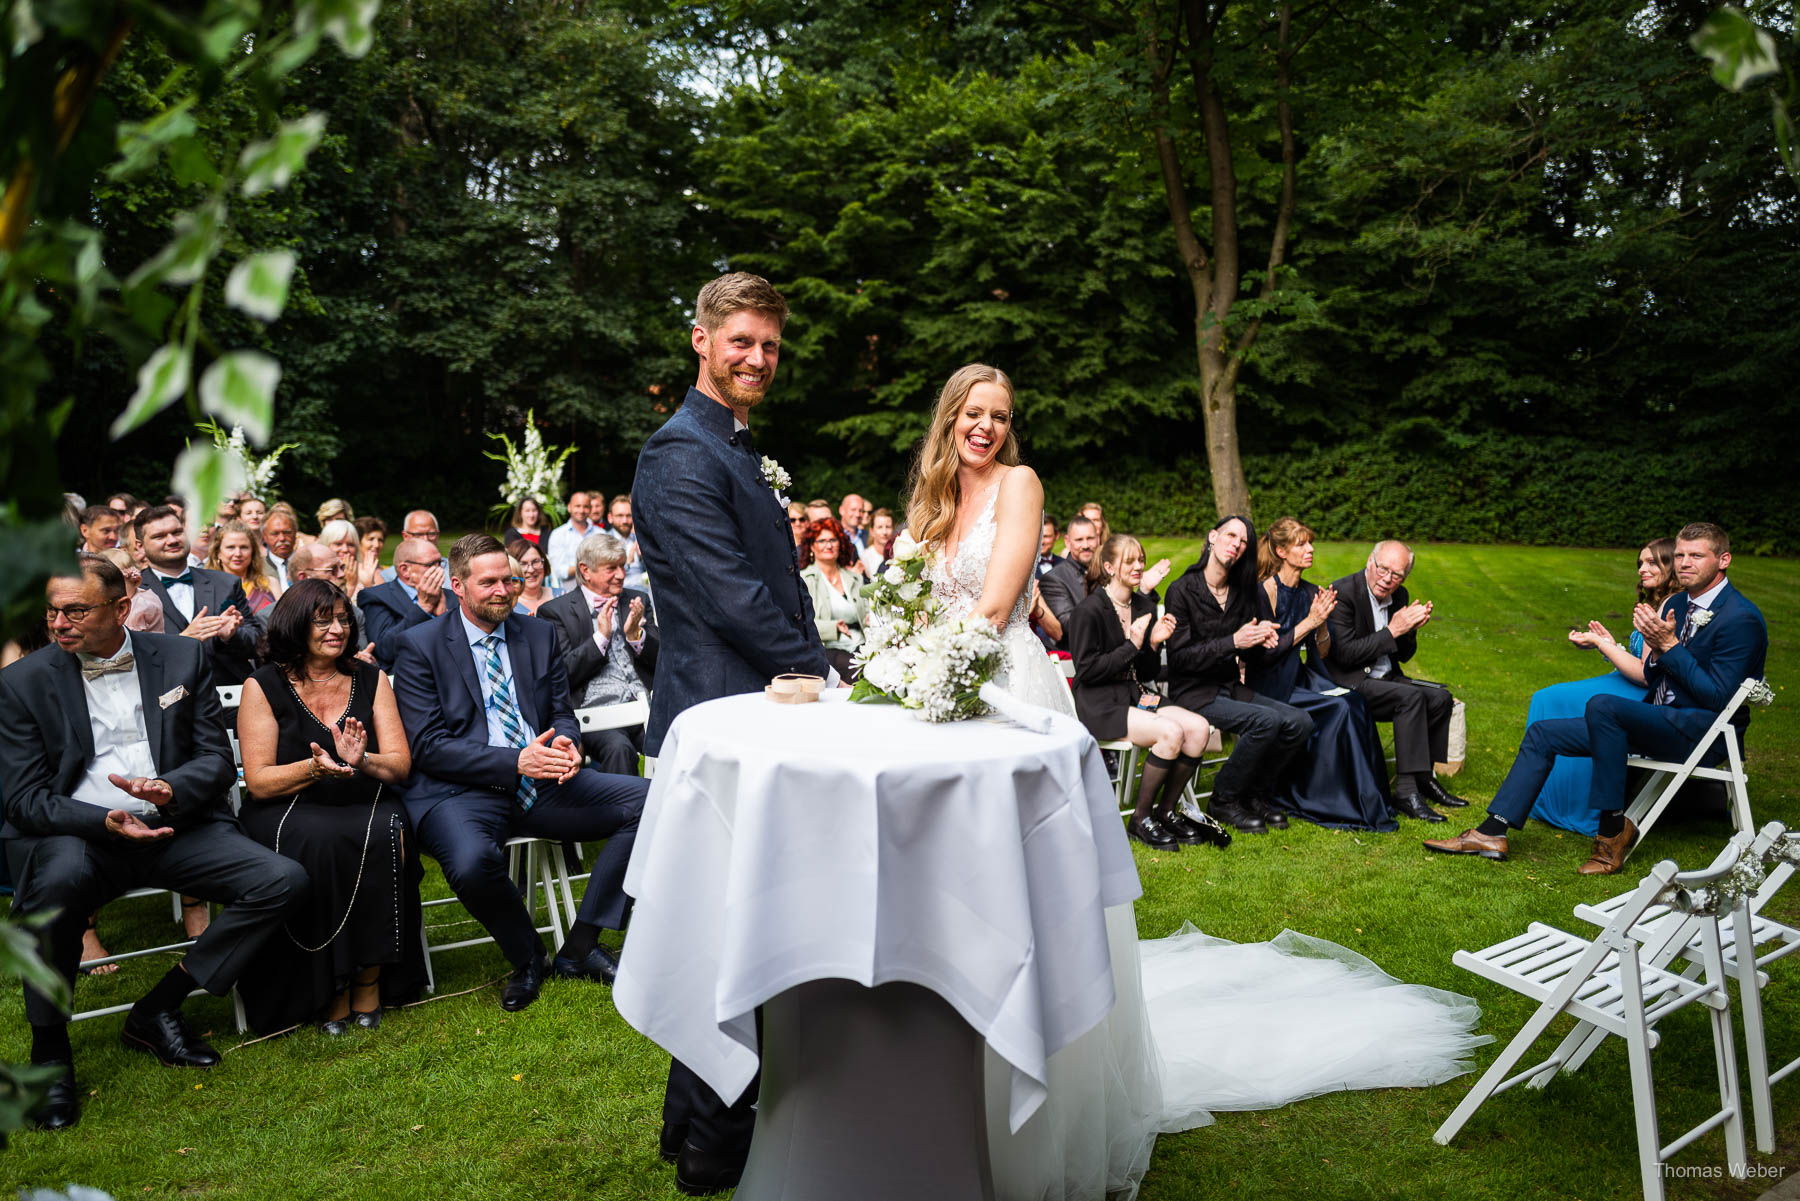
[612,693,1139,1131]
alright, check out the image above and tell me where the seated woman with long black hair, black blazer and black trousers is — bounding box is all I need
[1168,517,1312,834]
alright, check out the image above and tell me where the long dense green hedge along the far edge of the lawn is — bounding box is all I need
[1044,434,1800,555]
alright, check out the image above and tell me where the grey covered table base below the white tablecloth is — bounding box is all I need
[736,980,994,1201]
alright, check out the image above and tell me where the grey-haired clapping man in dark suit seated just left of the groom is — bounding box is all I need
[538,531,659,776]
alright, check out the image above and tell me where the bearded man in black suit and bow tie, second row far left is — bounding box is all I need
[131,504,263,684]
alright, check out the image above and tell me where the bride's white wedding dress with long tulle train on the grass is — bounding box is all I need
[927,486,1490,1201]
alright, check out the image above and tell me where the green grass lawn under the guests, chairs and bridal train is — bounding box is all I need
[0,540,1800,1201]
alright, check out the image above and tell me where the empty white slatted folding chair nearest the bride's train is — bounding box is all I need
[1433,841,1748,1201]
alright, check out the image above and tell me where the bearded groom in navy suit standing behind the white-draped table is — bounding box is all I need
[632,272,830,1196]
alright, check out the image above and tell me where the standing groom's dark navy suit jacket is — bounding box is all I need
[632,387,828,756]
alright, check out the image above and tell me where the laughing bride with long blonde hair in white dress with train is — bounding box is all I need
[907,364,1489,1201]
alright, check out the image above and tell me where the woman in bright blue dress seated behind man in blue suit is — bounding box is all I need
[1525,538,1676,837]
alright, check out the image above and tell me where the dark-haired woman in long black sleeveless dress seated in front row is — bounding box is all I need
[238,580,425,1035]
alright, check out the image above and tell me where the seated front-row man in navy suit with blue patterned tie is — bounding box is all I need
[394,533,650,1010]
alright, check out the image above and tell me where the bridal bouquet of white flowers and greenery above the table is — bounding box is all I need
[850,533,1003,722]
